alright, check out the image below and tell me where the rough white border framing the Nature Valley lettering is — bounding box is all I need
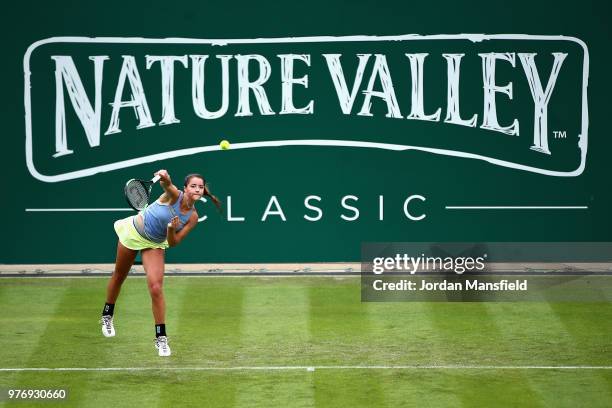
[23,34,589,183]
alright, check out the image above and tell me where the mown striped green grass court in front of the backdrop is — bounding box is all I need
[0,276,612,407]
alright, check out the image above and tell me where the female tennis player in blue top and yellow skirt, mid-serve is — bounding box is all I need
[101,170,221,357]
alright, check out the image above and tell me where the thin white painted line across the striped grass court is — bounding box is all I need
[0,365,612,372]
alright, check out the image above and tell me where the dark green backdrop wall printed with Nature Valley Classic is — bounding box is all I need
[0,1,612,263]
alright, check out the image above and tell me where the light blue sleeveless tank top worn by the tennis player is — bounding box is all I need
[142,191,193,242]
